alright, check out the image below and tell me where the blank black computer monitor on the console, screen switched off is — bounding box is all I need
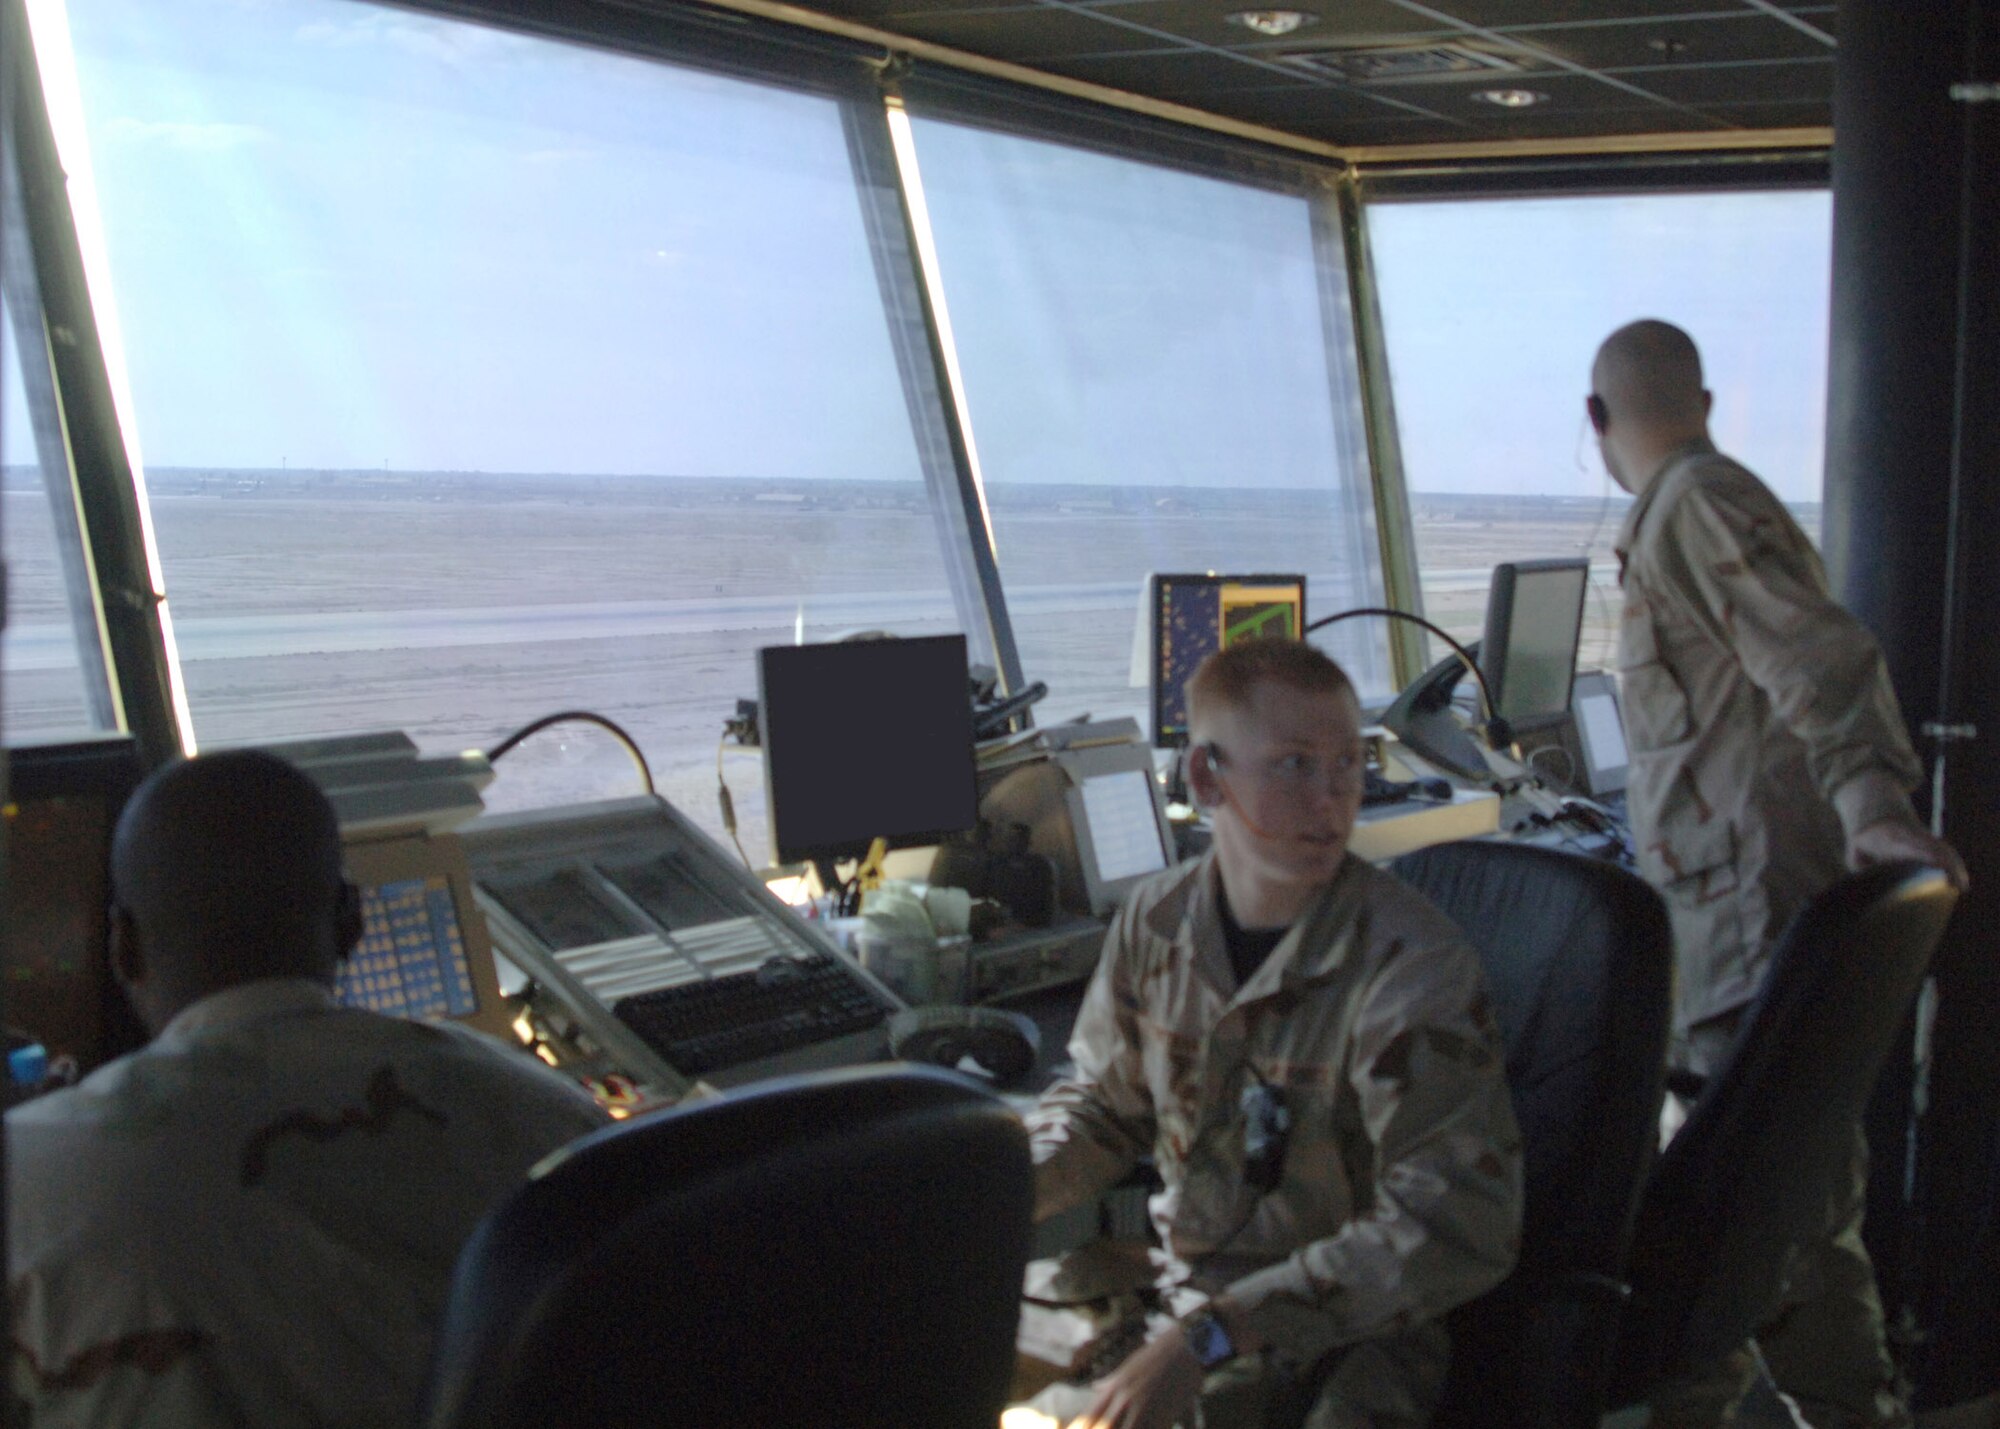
[758,634,978,863]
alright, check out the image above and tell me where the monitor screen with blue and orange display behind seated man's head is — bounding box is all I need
[1152,574,1306,749]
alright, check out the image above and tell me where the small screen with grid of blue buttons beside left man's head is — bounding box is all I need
[334,875,478,1021]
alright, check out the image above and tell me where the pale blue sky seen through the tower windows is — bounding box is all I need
[6,0,1830,498]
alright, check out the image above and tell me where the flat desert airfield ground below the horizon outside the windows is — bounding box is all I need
[0,474,1816,863]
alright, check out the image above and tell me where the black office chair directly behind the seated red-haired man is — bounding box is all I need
[1392,843,1674,1429]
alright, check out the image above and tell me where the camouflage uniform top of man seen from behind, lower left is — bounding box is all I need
[6,979,604,1429]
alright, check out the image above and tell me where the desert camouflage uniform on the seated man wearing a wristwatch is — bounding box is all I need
[1030,855,1520,1429]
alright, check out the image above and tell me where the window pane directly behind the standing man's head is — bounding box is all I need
[1368,192,1832,668]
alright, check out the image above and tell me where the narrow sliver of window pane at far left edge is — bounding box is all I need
[0,312,112,745]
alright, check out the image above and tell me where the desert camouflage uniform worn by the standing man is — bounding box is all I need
[1618,440,1922,1427]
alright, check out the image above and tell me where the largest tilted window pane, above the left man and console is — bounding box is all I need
[58,0,960,857]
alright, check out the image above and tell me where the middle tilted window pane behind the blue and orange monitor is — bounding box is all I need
[914,118,1390,727]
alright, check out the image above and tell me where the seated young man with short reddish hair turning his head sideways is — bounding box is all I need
[1030,640,1520,1429]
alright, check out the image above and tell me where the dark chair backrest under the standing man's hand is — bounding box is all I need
[1614,863,1958,1403]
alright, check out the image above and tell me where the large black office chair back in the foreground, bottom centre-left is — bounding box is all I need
[420,1067,1032,1429]
